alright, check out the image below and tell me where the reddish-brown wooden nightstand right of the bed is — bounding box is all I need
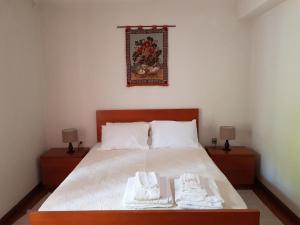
[205,146,256,188]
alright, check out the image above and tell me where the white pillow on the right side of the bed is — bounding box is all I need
[150,120,199,148]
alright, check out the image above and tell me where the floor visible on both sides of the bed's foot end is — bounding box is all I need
[9,190,294,225]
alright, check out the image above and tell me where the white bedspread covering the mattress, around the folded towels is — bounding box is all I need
[39,145,247,211]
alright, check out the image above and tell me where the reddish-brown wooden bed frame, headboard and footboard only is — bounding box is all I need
[29,109,260,225]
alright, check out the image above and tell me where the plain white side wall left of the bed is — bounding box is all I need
[0,0,45,218]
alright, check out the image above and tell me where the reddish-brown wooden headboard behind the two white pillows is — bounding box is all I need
[96,108,199,142]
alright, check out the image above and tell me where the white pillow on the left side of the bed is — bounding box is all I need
[101,122,149,150]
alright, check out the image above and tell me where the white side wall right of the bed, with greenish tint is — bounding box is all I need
[251,0,300,216]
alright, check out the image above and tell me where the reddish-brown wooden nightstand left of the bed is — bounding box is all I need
[40,148,89,189]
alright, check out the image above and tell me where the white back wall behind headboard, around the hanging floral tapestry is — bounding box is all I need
[42,0,250,147]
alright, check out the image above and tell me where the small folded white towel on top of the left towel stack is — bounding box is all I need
[134,172,160,201]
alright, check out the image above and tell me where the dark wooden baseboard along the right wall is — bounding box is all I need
[254,179,300,224]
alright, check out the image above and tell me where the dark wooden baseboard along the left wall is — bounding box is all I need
[0,183,43,225]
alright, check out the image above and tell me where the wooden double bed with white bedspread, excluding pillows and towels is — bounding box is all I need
[30,109,259,225]
